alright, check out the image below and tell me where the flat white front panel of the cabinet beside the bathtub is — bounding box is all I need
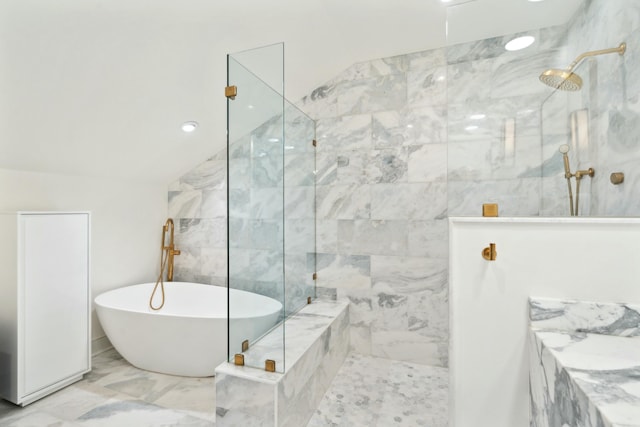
[20,214,89,395]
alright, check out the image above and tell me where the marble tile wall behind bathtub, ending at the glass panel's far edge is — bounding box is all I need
[169,105,315,314]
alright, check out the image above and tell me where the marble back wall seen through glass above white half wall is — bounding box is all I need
[447,27,566,216]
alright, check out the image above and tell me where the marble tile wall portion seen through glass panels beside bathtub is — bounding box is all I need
[229,104,315,315]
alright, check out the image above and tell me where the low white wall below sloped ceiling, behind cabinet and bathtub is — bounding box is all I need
[0,169,167,339]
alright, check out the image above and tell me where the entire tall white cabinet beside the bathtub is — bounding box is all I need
[0,212,91,405]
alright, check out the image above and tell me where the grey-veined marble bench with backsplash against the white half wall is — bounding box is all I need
[529,299,640,427]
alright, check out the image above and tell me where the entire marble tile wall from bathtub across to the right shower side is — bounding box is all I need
[169,0,640,372]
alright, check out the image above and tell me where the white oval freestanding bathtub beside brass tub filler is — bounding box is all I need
[95,282,282,377]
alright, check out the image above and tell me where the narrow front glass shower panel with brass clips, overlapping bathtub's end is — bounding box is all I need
[227,44,286,372]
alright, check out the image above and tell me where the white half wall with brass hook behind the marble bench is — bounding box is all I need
[449,218,640,427]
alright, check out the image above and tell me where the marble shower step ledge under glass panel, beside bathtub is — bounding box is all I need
[216,301,349,427]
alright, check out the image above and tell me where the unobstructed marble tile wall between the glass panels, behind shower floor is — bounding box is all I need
[299,50,448,366]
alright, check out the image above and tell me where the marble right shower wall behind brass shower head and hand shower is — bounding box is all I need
[542,0,640,216]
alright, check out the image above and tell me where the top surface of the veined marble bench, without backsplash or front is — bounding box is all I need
[533,330,640,427]
